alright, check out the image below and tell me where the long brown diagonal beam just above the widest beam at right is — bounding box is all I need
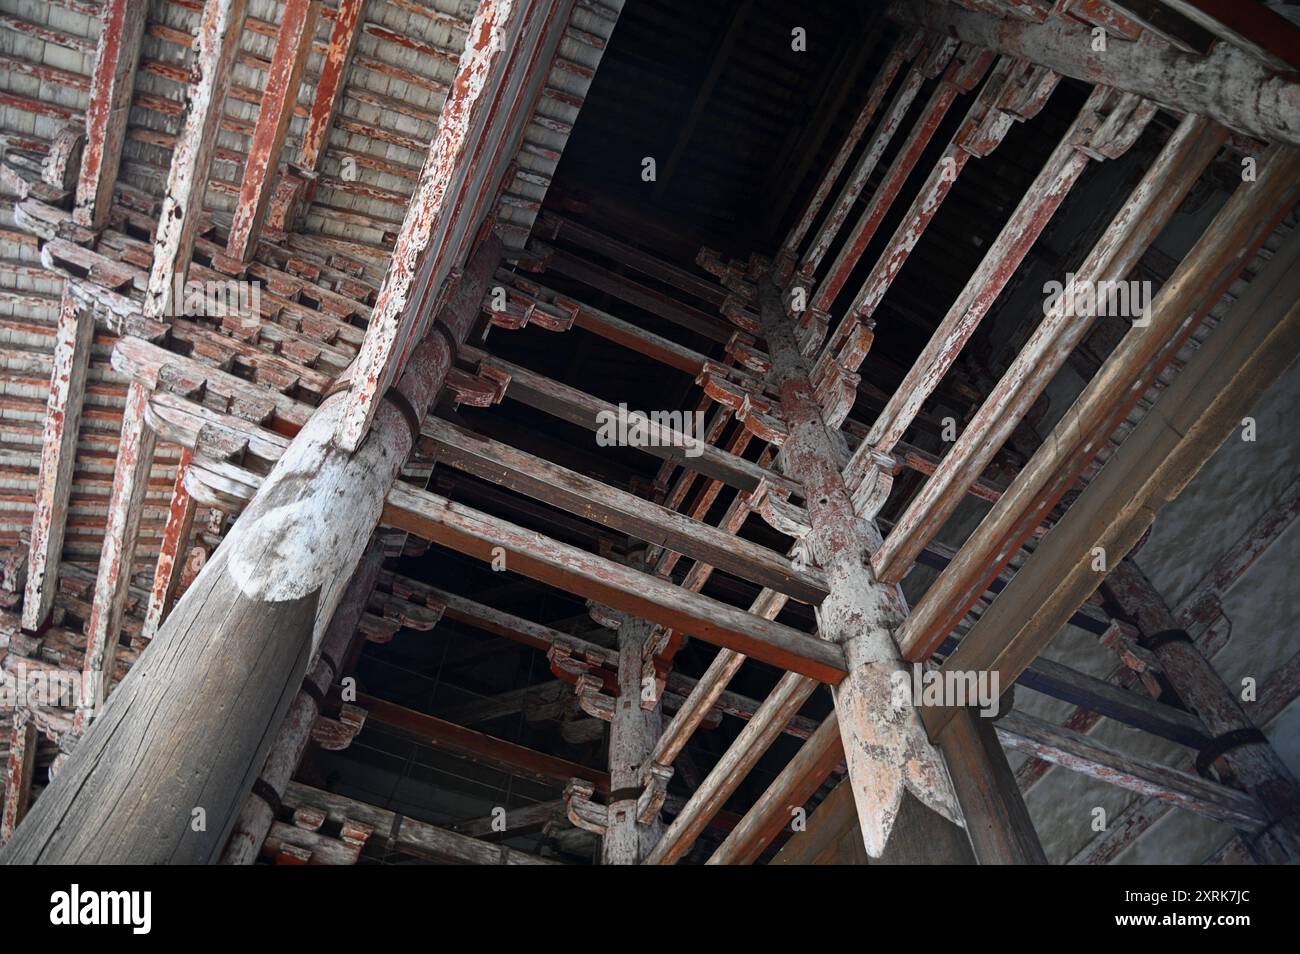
[898,147,1300,665]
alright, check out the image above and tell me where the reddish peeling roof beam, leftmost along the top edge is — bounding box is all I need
[73,0,148,231]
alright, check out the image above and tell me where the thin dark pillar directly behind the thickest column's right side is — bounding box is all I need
[221,542,384,864]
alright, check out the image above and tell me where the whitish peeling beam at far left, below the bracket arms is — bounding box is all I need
[22,289,95,630]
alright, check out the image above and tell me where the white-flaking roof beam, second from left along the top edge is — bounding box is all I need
[144,0,248,320]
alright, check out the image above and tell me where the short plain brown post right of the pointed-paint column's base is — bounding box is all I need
[939,701,1048,864]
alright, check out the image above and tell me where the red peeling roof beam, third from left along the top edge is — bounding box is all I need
[226,0,319,263]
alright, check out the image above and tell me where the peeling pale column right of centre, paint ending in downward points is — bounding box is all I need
[759,278,961,860]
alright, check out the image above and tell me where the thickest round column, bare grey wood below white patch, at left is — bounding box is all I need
[0,239,499,863]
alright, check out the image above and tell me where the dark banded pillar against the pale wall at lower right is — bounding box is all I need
[1105,558,1300,864]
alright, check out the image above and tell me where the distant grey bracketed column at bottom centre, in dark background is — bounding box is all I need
[601,613,663,864]
